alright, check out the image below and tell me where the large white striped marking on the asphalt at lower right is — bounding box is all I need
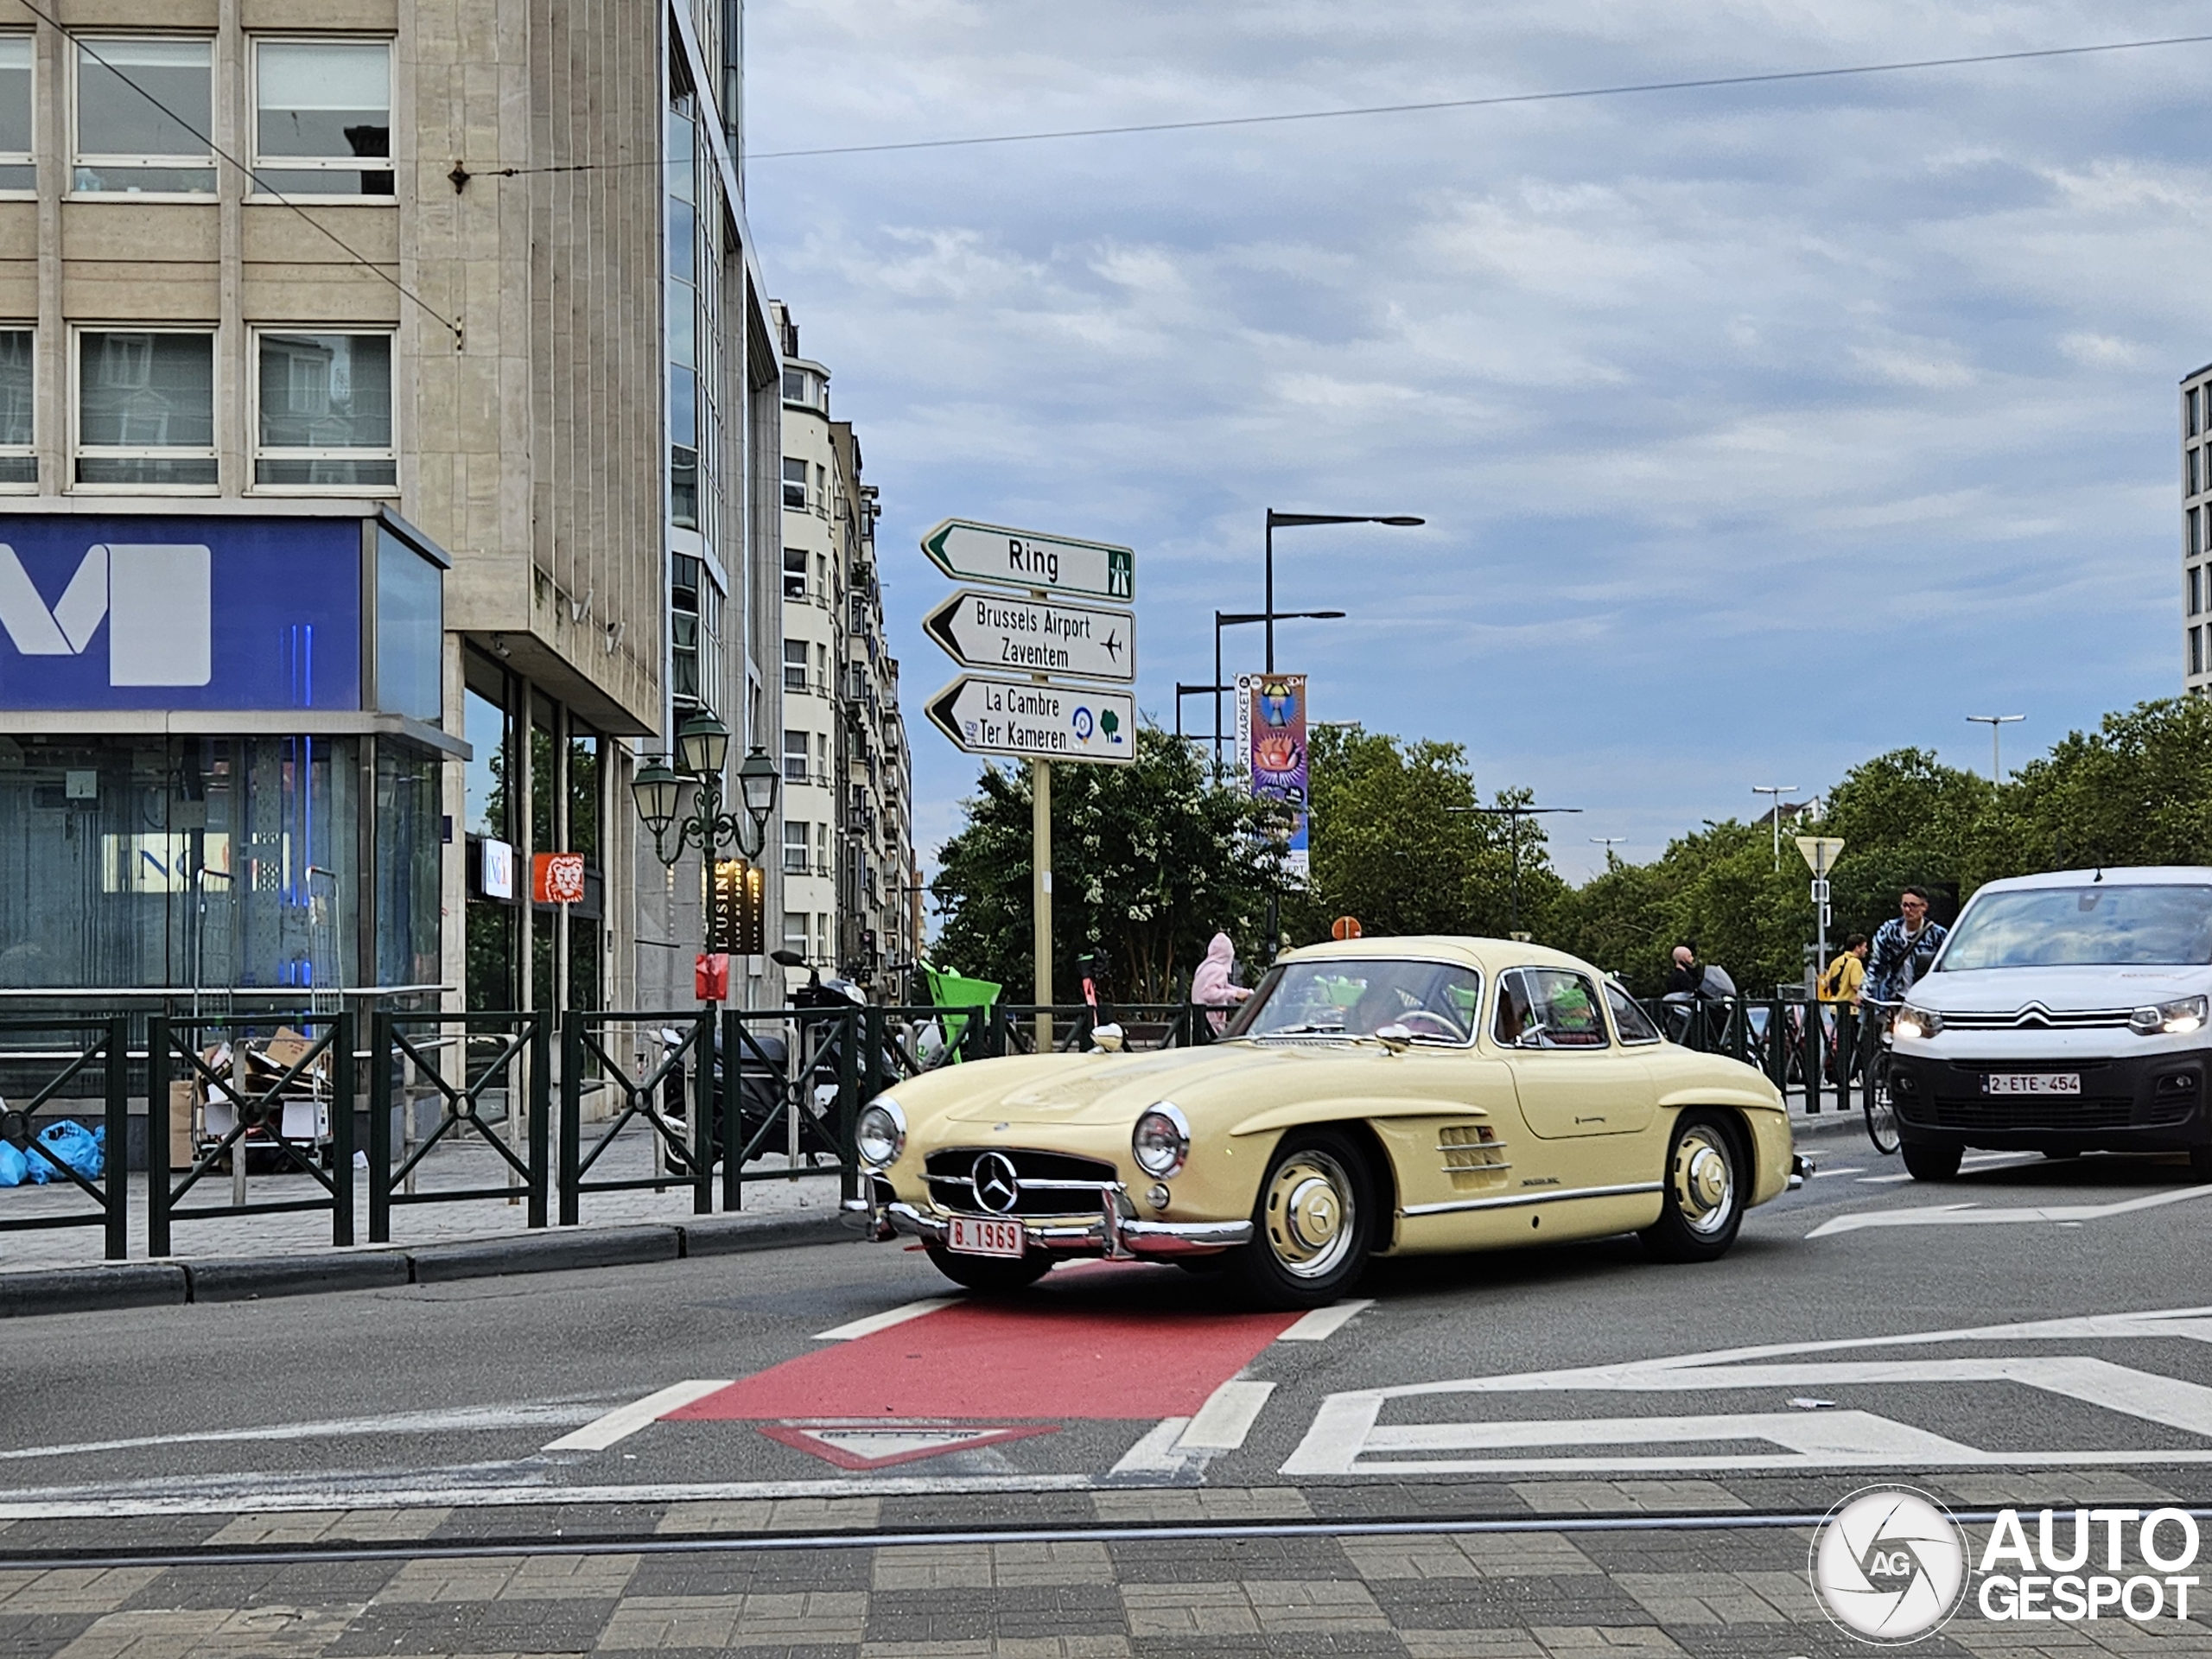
[1283,1307,2212,1476]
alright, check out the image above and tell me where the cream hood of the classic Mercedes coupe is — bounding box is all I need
[898,1042,1353,1123]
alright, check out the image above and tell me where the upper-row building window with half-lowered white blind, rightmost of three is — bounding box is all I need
[254,40,391,199]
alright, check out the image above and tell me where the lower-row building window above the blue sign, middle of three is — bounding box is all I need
[78,329,214,489]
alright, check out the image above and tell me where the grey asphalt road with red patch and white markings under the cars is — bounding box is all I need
[0,1141,2212,1517]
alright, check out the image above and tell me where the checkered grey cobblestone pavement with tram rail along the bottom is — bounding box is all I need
[0,1476,2212,1659]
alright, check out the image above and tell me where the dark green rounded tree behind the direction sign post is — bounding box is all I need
[931,726,1281,1002]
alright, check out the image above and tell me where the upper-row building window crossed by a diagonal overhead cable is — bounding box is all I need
[73,38,214,194]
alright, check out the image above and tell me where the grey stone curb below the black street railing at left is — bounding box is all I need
[0,1210,861,1320]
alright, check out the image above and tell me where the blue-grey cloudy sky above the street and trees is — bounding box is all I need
[747,0,2212,872]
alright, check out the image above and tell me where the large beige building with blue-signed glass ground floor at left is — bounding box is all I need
[0,0,779,1007]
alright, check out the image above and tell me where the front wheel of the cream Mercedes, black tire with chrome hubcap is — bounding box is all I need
[1225,1128,1378,1307]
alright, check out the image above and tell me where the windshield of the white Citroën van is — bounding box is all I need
[1936,882,2212,973]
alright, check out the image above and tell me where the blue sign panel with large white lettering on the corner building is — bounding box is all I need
[0,513,360,710]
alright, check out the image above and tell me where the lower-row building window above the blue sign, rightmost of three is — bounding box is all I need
[254,334,400,489]
